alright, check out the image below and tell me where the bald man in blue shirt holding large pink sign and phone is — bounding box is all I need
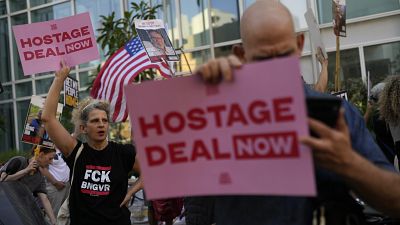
[185,0,400,225]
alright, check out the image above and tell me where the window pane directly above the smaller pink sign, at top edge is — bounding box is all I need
[32,2,71,23]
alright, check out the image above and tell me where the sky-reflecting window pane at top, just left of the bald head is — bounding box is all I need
[211,0,240,43]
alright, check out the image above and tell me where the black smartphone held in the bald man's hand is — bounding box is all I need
[306,96,342,127]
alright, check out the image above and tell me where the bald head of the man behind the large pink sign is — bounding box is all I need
[233,0,304,63]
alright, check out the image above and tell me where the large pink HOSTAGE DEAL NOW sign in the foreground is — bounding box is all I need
[125,58,316,199]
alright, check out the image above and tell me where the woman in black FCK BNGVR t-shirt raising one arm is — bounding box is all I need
[42,61,142,225]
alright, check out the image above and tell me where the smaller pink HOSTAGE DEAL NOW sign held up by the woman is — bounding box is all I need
[13,13,99,75]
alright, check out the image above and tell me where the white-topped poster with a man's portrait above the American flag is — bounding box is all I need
[135,19,179,62]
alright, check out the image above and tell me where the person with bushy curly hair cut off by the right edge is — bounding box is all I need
[378,75,400,169]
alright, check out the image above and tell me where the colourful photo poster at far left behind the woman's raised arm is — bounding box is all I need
[21,95,63,148]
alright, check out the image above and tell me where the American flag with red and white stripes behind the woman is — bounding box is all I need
[90,37,171,122]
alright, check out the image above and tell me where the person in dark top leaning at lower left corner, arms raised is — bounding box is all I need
[0,146,56,224]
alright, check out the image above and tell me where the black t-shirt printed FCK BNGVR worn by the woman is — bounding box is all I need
[66,142,136,225]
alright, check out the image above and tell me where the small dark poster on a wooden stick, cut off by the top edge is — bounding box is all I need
[332,0,346,37]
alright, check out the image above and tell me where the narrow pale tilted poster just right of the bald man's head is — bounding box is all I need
[304,8,328,59]
